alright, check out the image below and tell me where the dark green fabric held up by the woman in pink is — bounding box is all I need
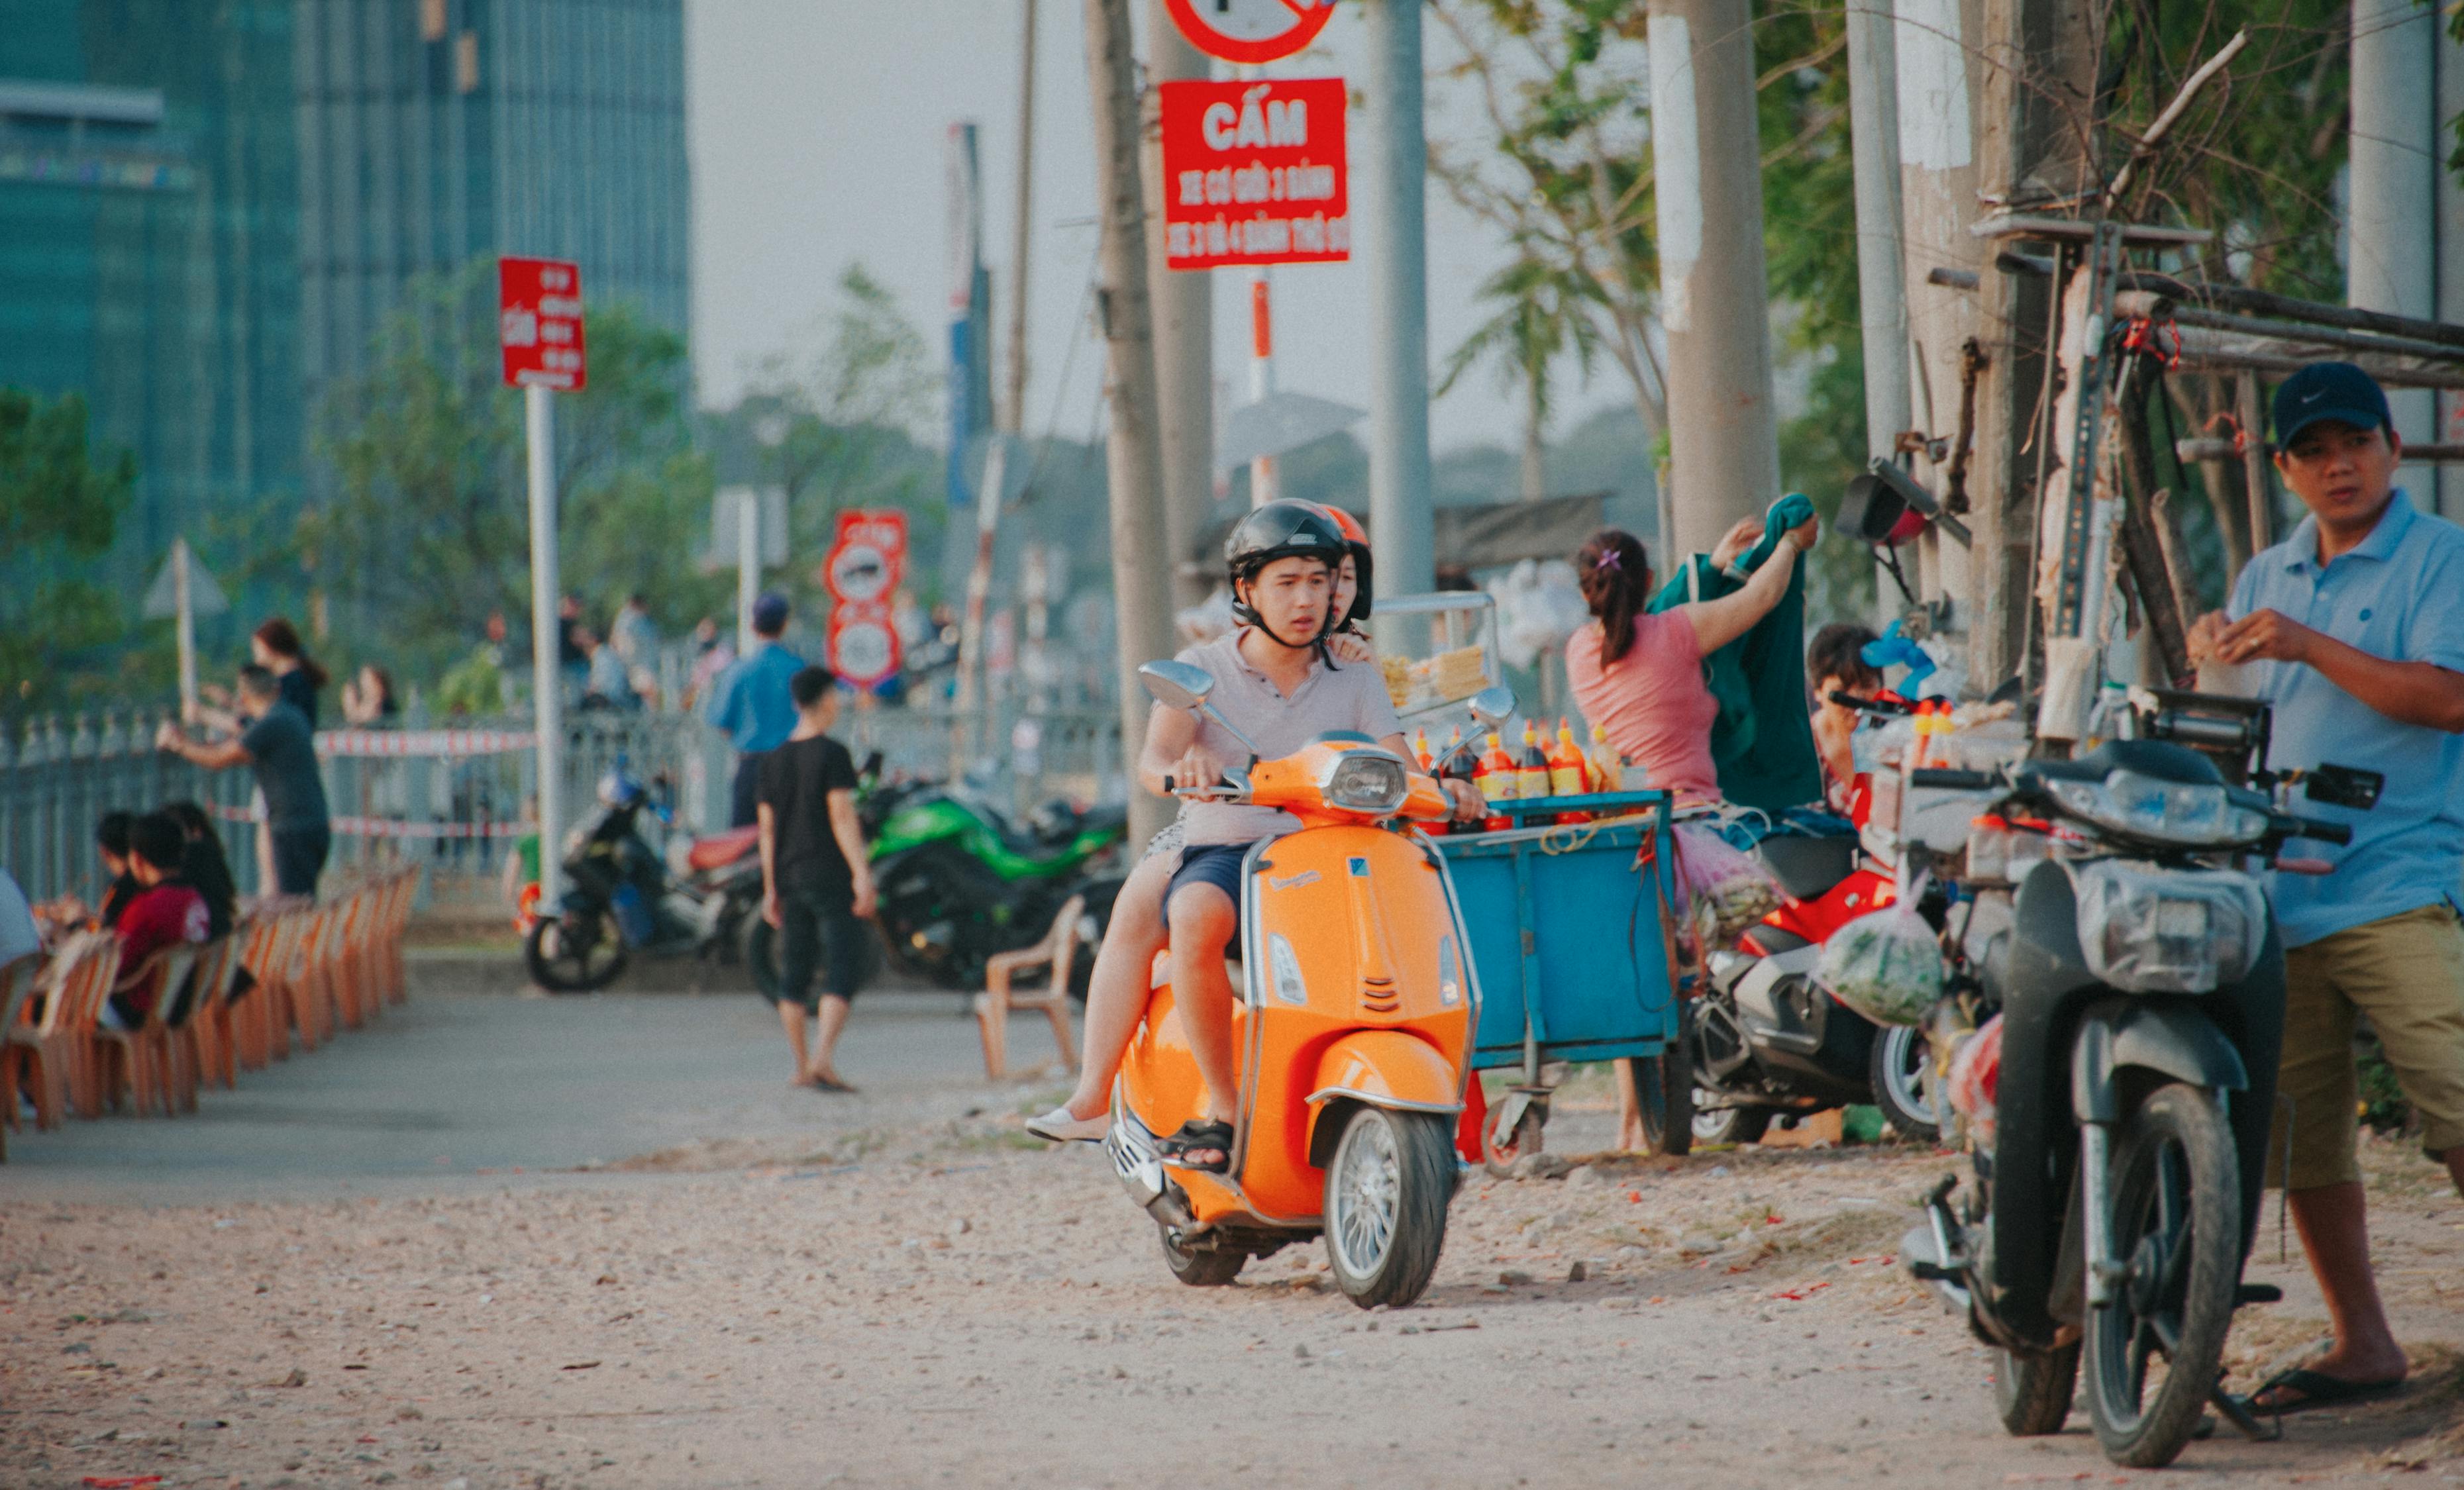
[1651,493,1823,813]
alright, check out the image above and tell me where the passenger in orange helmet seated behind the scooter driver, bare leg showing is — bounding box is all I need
[1027,505,1377,1143]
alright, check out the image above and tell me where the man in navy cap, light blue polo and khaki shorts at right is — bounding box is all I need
[2190,362,2464,1411]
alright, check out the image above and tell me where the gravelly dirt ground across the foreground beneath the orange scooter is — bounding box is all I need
[14,1089,2464,1490]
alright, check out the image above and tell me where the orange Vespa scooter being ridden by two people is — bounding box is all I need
[1104,662,1513,1308]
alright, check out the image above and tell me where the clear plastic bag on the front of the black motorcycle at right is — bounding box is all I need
[2073,860,2267,993]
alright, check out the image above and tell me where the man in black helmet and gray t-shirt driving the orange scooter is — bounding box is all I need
[1029,503,1481,1172]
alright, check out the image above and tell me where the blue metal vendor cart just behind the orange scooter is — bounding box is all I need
[1437,791,1680,1170]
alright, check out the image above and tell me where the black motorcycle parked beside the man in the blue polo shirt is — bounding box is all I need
[1900,695,2378,1468]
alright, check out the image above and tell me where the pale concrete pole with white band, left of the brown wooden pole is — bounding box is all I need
[1892,0,1984,621]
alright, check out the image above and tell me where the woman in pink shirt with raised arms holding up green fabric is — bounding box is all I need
[1565,517,1814,808]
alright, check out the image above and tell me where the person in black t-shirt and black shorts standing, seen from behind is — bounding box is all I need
[756,668,872,1091]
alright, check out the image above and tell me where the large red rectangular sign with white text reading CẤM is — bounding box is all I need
[1160,79,1353,268]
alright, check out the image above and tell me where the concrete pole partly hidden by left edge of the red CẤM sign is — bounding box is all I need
[1143,0,1215,606]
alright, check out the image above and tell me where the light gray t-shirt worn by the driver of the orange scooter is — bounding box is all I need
[1175,630,1402,847]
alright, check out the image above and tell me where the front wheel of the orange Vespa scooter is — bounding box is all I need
[1323,1106,1454,1308]
